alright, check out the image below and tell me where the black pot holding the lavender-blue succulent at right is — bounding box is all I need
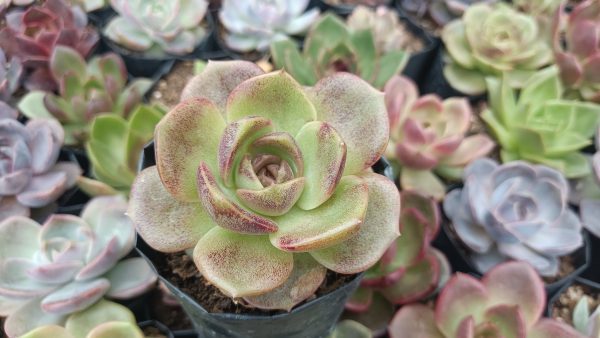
[433,219,591,297]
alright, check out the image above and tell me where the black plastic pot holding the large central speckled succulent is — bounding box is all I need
[136,142,392,338]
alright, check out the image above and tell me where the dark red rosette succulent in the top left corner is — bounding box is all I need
[0,0,98,91]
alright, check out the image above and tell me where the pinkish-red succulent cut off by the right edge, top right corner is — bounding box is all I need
[554,0,600,103]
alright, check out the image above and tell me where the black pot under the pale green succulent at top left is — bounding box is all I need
[98,10,214,81]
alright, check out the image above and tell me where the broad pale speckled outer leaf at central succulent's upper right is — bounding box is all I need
[310,73,389,175]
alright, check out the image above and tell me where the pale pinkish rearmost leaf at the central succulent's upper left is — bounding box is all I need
[181,60,264,114]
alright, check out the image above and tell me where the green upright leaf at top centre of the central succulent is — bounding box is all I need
[227,71,317,135]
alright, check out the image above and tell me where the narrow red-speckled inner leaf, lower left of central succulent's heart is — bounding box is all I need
[198,162,277,234]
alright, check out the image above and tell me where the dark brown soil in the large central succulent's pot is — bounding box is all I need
[154,252,356,316]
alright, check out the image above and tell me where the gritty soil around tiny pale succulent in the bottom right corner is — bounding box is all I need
[551,284,600,325]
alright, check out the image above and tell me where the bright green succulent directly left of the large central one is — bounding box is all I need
[78,105,165,196]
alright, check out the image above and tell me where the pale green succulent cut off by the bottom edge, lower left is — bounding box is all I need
[20,299,144,338]
